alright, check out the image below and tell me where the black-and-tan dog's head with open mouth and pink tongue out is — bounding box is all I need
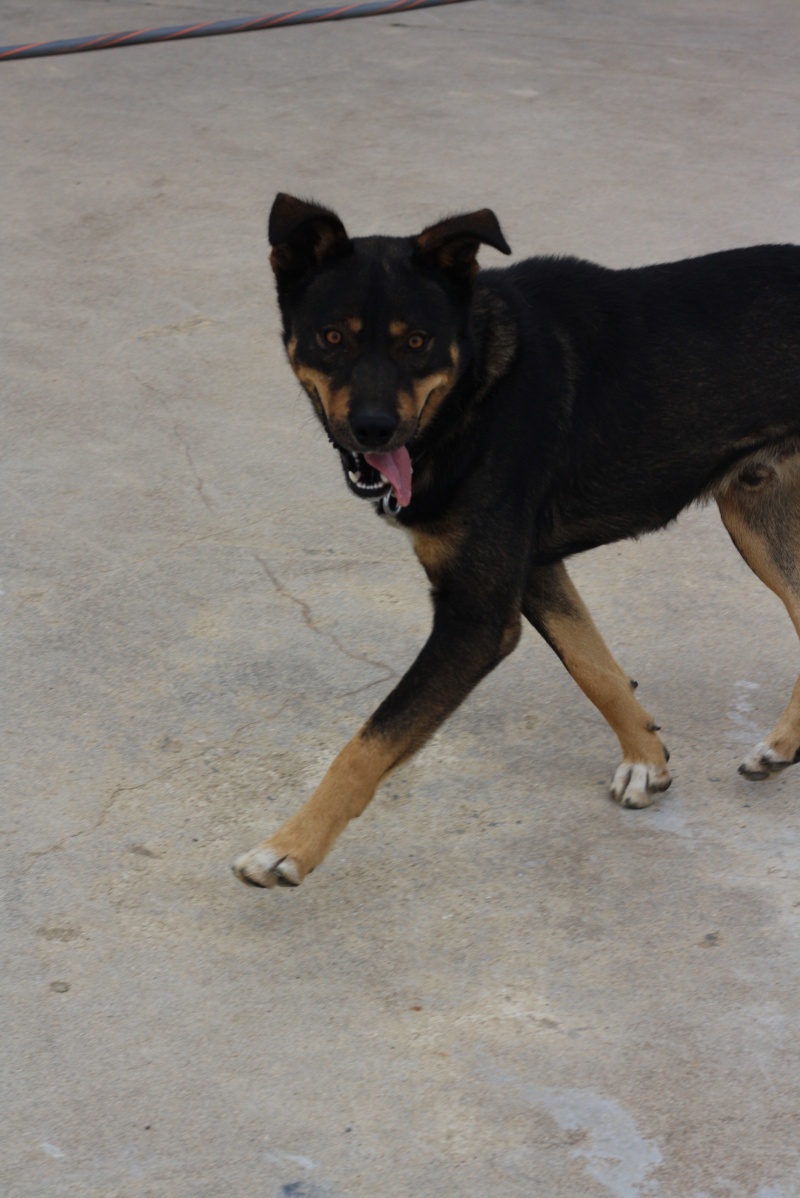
[269,194,510,510]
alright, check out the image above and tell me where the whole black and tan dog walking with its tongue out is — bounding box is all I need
[234,195,800,887]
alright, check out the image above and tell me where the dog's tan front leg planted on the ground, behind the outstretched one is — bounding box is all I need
[522,562,672,807]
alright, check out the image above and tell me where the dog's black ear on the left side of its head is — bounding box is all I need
[268,192,352,288]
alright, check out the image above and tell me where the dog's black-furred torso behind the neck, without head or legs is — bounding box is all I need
[469,246,800,556]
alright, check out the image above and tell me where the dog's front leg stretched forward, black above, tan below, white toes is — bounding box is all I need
[234,588,520,887]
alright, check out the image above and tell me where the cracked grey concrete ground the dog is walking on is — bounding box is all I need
[0,0,800,1198]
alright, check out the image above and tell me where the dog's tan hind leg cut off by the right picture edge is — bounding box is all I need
[716,454,800,779]
